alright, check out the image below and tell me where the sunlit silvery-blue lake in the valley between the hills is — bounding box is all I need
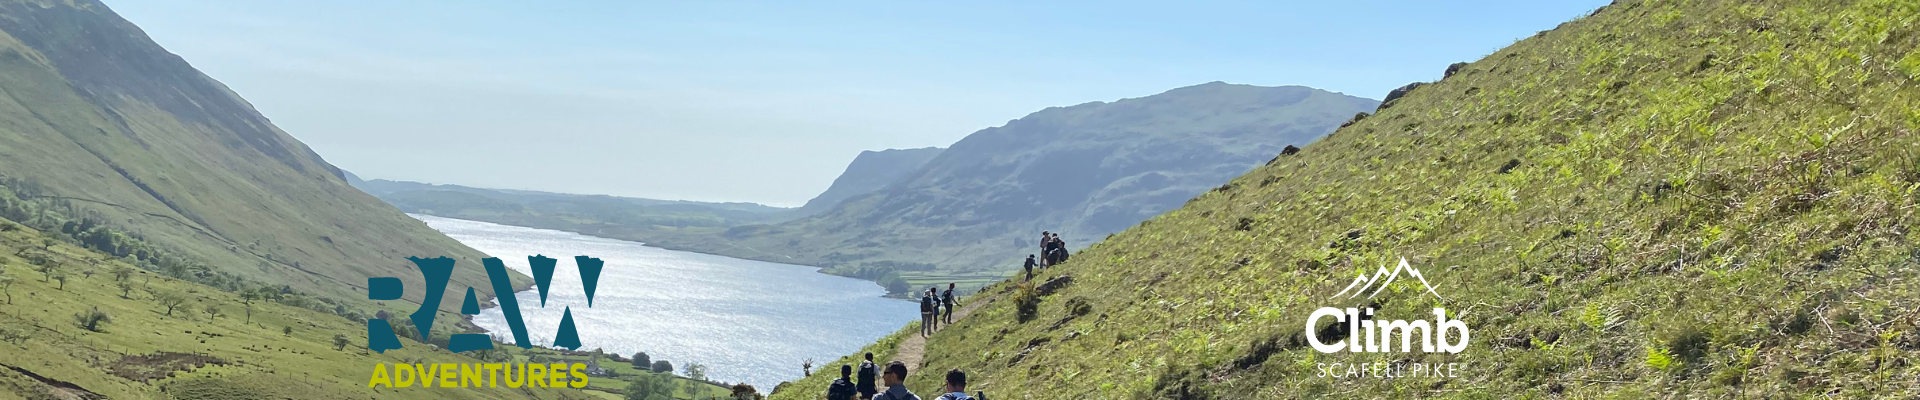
[413,215,920,392]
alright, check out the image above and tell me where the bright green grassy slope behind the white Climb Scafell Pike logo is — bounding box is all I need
[774,0,1920,398]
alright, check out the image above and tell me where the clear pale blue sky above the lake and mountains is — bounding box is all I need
[106,0,1605,206]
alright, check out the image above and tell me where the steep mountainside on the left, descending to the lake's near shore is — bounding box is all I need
[0,0,522,306]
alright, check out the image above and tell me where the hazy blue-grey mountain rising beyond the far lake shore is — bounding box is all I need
[657,83,1377,281]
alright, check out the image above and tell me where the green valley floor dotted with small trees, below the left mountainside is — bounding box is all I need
[0,219,728,400]
